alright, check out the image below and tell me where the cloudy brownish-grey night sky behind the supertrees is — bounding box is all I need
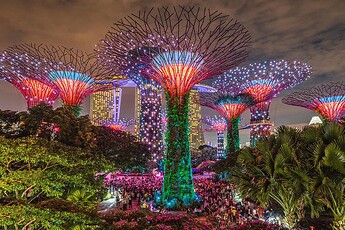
[0,0,345,142]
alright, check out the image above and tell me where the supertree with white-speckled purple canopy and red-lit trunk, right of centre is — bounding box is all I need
[215,60,311,147]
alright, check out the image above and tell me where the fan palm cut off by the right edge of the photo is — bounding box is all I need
[302,123,345,230]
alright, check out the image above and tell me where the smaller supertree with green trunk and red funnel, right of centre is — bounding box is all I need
[200,92,257,156]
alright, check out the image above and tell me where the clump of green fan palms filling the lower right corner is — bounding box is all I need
[231,123,345,229]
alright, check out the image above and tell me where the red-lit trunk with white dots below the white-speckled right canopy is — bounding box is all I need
[250,100,271,148]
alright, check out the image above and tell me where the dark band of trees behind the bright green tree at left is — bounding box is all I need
[0,104,151,170]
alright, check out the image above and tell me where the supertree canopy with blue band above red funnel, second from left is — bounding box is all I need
[6,44,109,114]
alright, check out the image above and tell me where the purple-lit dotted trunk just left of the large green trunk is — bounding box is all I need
[139,86,164,163]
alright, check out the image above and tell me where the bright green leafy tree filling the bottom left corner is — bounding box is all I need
[0,136,111,229]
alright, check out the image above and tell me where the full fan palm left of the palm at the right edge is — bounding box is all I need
[235,126,310,228]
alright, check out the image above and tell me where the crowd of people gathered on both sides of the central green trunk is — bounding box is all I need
[106,172,273,226]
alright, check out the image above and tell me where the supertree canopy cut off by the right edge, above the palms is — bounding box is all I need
[282,82,345,123]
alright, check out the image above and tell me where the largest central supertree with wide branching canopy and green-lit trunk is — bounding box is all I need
[98,7,250,208]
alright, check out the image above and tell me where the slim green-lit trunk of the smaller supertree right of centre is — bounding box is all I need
[226,117,240,156]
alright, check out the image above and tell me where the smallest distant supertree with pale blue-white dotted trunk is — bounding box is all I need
[201,116,227,160]
